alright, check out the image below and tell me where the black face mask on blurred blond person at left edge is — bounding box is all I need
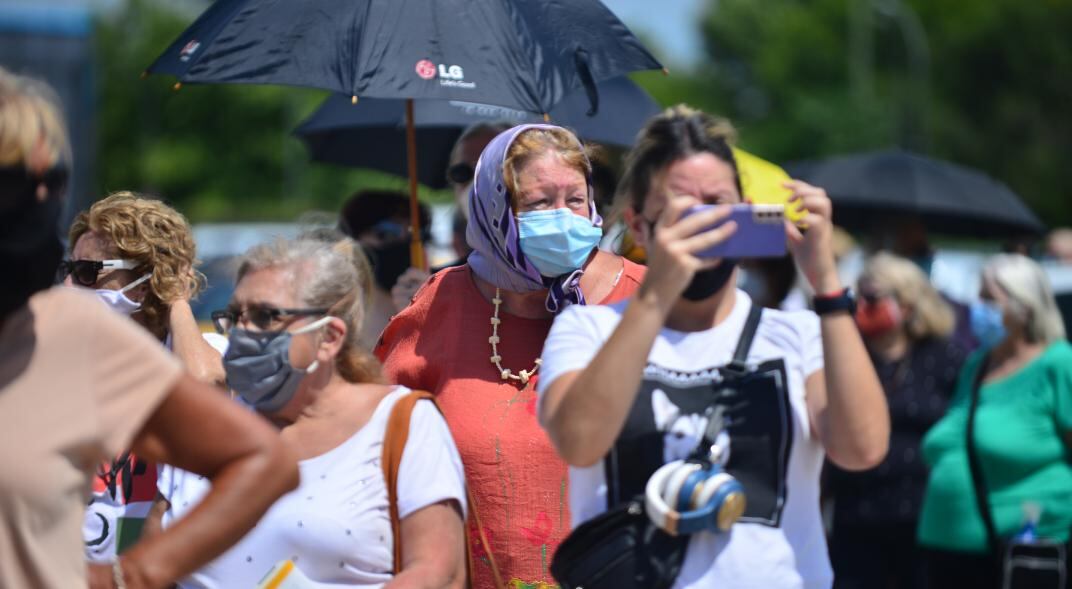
[0,186,63,318]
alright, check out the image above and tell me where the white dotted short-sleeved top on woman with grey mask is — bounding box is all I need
[160,386,465,589]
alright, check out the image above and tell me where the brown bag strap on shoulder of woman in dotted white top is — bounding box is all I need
[381,391,506,589]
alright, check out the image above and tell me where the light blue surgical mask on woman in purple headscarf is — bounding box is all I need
[518,208,602,278]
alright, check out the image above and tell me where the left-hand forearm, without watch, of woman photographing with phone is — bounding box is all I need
[541,291,667,467]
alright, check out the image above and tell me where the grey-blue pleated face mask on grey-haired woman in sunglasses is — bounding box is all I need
[223,316,331,413]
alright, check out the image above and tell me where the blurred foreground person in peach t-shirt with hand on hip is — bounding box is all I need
[0,68,298,589]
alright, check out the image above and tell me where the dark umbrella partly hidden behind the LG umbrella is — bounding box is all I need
[295,77,659,188]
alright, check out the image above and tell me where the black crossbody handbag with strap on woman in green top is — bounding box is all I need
[966,358,1069,589]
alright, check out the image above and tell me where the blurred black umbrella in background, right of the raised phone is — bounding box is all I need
[786,149,1045,237]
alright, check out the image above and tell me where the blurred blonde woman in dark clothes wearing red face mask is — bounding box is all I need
[827,252,968,588]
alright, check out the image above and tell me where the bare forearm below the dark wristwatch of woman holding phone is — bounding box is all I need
[808,313,890,470]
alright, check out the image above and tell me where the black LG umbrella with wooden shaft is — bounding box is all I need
[142,0,661,266]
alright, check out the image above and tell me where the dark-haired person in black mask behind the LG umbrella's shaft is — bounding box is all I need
[339,190,431,350]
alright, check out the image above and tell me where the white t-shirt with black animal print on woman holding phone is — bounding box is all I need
[538,290,833,589]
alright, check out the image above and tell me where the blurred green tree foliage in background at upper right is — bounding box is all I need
[639,0,1072,225]
